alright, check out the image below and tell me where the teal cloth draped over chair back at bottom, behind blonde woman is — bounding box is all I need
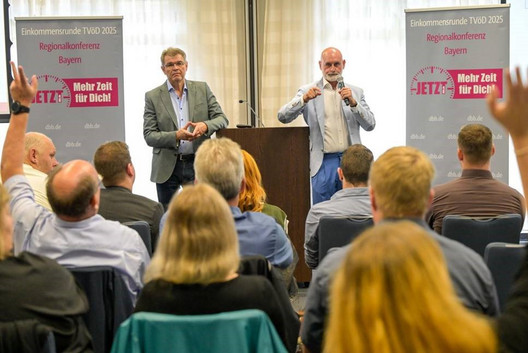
[112,310,287,353]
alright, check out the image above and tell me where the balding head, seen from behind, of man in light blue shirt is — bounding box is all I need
[46,160,99,221]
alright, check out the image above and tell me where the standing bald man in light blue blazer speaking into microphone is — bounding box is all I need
[278,48,376,204]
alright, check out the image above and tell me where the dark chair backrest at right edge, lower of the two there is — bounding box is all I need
[484,242,526,311]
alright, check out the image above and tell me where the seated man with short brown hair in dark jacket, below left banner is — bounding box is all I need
[94,141,164,249]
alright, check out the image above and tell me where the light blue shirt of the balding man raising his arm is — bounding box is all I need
[4,175,150,302]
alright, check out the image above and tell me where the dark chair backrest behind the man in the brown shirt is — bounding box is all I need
[442,214,522,256]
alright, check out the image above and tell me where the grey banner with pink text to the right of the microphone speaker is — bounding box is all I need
[405,5,510,184]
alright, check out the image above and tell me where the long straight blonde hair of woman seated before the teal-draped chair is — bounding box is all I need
[145,184,240,284]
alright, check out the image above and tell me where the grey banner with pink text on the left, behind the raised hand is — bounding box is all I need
[15,17,125,163]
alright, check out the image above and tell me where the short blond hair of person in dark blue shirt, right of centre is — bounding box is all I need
[369,146,435,218]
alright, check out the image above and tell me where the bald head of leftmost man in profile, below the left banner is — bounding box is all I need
[24,132,59,174]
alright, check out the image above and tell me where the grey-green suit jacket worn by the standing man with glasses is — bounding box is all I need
[143,80,229,184]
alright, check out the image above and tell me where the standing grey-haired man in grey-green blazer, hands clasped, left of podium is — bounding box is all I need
[143,48,229,209]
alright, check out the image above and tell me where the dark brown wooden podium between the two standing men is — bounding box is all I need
[216,127,311,282]
